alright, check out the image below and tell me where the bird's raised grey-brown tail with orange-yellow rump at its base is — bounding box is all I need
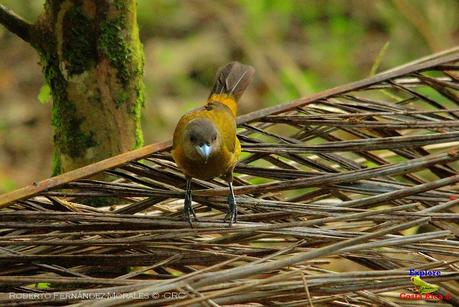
[208,62,255,116]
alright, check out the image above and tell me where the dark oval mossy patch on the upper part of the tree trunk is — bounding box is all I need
[62,3,97,75]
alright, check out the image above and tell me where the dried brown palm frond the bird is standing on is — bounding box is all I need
[0,48,459,306]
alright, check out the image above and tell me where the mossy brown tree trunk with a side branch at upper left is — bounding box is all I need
[0,0,144,174]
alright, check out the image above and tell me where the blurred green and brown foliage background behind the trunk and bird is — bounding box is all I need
[0,0,459,192]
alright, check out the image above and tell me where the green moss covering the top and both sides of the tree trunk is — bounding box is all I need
[35,0,144,175]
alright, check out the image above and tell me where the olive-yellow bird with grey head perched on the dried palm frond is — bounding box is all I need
[171,62,255,227]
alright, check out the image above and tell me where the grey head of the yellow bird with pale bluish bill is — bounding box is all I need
[184,118,220,163]
